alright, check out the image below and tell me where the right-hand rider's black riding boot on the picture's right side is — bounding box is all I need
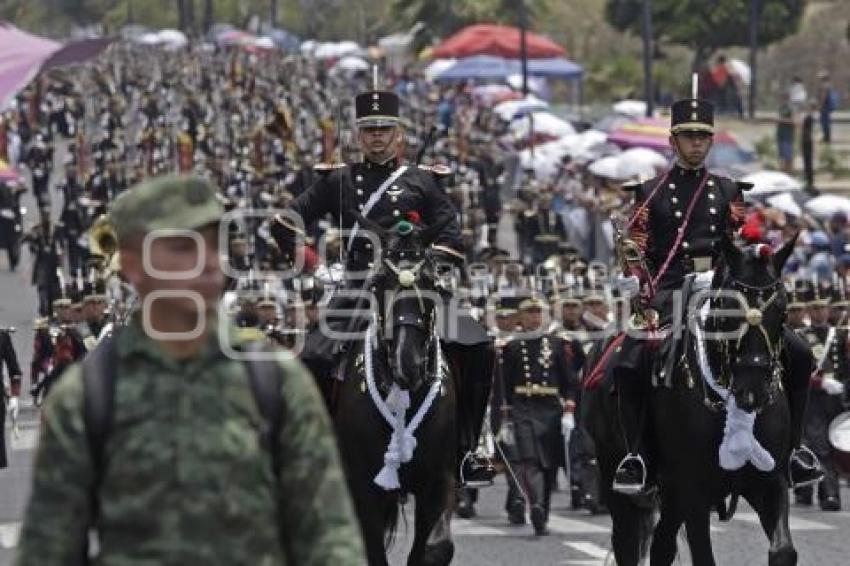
[782,327,823,486]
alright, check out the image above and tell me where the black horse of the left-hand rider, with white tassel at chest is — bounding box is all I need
[334,217,457,566]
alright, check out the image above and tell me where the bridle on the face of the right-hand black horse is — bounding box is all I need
[711,269,785,405]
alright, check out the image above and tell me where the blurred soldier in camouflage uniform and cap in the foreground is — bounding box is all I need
[16,177,365,566]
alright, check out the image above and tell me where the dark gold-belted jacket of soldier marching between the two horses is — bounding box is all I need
[502,335,576,469]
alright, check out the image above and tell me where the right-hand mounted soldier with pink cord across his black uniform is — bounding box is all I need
[590,99,822,500]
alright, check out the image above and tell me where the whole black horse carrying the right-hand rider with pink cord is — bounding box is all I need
[585,238,797,566]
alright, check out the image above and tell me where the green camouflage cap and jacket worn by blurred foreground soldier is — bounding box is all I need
[16,175,365,566]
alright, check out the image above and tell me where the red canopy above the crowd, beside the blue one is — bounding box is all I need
[432,24,567,59]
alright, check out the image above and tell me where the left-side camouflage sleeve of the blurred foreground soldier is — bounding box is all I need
[15,365,94,566]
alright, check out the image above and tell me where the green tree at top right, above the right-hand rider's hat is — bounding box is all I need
[605,0,806,67]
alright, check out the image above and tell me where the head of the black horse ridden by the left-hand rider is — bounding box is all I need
[358,213,449,391]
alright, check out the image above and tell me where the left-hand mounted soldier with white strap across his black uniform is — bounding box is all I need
[270,90,493,483]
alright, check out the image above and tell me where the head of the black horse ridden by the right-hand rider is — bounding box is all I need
[714,236,797,412]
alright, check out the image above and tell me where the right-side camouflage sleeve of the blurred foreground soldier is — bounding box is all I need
[280,361,366,566]
